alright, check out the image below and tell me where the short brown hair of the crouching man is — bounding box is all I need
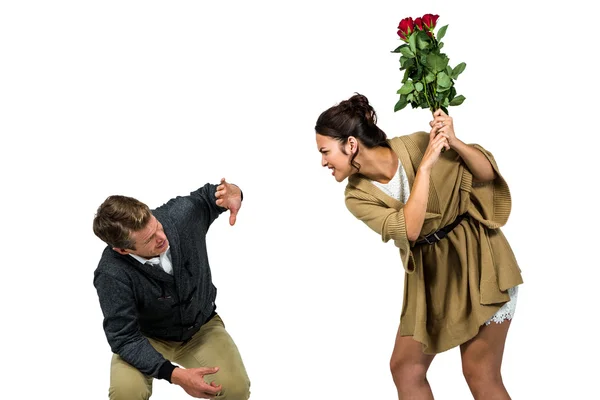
[94,195,152,250]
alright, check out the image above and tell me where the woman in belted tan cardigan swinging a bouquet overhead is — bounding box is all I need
[315,94,523,400]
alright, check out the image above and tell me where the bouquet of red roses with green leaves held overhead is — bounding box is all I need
[392,14,466,114]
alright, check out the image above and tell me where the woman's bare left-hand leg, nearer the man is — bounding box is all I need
[390,330,435,400]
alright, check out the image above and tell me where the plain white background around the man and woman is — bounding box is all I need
[0,0,600,400]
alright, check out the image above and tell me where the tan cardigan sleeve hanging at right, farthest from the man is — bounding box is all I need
[461,144,512,229]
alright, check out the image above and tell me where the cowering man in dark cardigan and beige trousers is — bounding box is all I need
[94,179,250,400]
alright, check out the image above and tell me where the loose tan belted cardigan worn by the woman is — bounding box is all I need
[345,132,523,354]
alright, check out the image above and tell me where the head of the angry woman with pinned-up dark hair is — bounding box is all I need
[315,93,389,182]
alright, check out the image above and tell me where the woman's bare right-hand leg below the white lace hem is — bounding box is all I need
[460,320,510,400]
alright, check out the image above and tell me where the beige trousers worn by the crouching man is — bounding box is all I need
[108,315,250,400]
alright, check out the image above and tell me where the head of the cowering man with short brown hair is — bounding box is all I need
[94,196,169,258]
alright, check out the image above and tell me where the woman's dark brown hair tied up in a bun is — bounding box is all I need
[315,93,390,170]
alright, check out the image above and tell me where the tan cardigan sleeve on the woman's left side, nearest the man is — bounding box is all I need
[345,188,415,274]
